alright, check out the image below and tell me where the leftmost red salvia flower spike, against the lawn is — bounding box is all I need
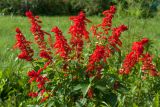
[14,28,34,61]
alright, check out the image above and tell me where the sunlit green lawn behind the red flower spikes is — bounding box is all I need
[0,16,160,72]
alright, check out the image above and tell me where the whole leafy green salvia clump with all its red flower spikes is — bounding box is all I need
[14,6,160,107]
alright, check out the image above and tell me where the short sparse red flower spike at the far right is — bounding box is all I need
[142,53,158,76]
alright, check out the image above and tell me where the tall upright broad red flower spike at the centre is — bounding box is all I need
[69,12,90,57]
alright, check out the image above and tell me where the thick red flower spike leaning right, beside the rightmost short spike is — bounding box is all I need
[119,38,149,74]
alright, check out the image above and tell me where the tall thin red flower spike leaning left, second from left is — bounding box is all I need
[26,11,51,59]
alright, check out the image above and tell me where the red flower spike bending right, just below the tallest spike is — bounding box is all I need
[108,25,128,51]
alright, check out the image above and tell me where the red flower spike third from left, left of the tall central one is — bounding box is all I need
[52,27,71,59]
